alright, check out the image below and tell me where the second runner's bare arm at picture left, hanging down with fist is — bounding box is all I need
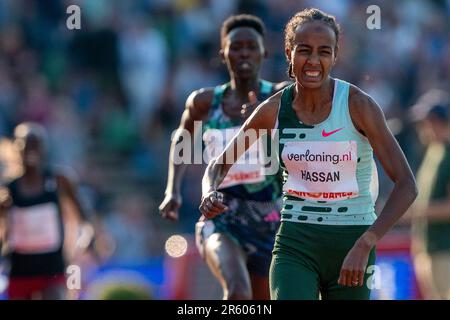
[159,88,214,221]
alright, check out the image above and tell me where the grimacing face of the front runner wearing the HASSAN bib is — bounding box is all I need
[286,21,337,89]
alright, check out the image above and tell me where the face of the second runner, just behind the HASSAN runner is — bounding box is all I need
[220,27,266,80]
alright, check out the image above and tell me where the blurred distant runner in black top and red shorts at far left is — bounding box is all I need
[0,123,93,300]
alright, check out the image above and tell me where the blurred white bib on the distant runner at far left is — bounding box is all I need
[8,203,62,254]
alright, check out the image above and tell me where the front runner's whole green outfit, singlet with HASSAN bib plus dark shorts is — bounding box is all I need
[269,79,378,300]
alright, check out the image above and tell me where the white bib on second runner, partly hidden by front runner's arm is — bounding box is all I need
[203,127,265,189]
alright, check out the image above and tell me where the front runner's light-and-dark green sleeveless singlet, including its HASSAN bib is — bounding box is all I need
[276,79,378,225]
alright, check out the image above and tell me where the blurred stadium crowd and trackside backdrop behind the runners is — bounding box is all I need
[0,0,450,299]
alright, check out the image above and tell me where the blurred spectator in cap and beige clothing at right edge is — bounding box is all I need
[412,97,450,299]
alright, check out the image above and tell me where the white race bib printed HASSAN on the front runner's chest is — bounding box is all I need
[282,141,359,201]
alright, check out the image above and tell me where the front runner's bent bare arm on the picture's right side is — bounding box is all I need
[339,88,418,286]
